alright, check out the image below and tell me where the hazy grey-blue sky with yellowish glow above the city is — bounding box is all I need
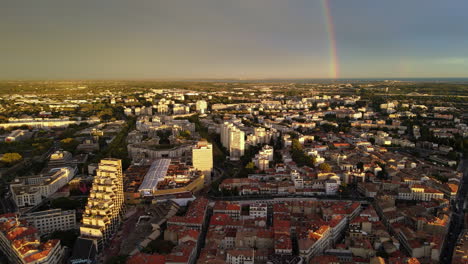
[0,0,468,80]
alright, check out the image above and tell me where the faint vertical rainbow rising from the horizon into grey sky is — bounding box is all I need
[321,0,340,79]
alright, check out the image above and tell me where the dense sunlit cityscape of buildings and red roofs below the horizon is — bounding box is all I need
[0,80,468,264]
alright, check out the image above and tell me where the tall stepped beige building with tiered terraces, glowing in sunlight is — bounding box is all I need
[80,159,124,250]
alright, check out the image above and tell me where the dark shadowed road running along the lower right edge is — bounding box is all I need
[440,159,468,264]
